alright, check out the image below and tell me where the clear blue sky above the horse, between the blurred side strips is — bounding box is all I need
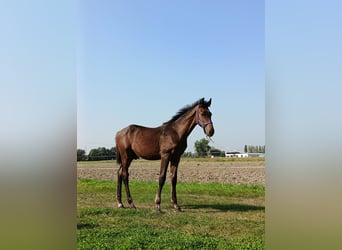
[77,1,265,151]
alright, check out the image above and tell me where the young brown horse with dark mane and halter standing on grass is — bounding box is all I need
[115,98,214,211]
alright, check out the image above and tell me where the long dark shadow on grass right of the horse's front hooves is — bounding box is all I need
[183,204,265,212]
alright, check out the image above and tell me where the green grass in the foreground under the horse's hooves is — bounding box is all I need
[77,179,265,249]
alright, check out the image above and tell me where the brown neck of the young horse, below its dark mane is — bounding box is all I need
[174,108,197,138]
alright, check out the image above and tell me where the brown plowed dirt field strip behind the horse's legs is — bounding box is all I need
[77,159,265,185]
